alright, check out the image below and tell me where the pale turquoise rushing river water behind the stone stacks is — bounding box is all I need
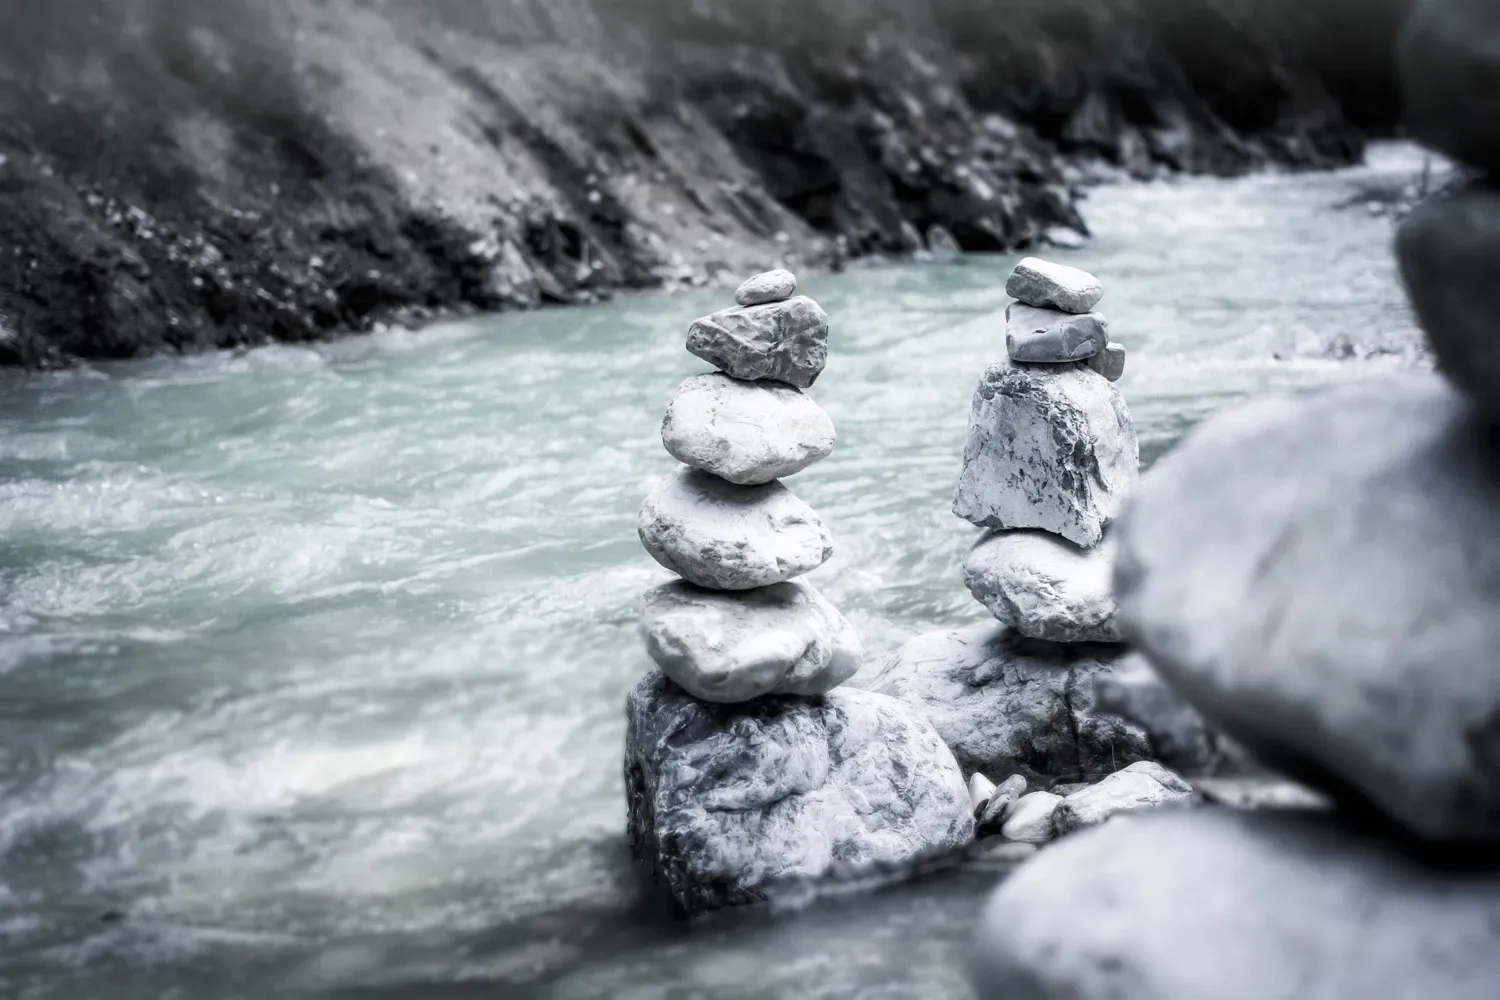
[0,147,1424,1000]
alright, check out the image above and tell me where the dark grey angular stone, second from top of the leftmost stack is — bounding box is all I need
[687,295,828,388]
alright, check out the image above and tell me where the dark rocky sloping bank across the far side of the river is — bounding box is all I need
[0,0,1407,366]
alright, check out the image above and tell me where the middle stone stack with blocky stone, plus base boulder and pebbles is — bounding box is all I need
[870,258,1214,843]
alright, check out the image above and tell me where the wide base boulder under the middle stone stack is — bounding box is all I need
[861,625,1151,780]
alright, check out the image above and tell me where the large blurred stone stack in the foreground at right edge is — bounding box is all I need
[972,0,1500,1000]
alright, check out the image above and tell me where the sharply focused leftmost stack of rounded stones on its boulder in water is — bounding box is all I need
[626,271,974,912]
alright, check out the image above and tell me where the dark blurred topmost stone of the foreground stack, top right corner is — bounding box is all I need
[1398,0,1500,174]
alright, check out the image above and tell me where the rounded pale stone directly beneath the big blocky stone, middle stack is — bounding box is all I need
[963,531,1121,642]
